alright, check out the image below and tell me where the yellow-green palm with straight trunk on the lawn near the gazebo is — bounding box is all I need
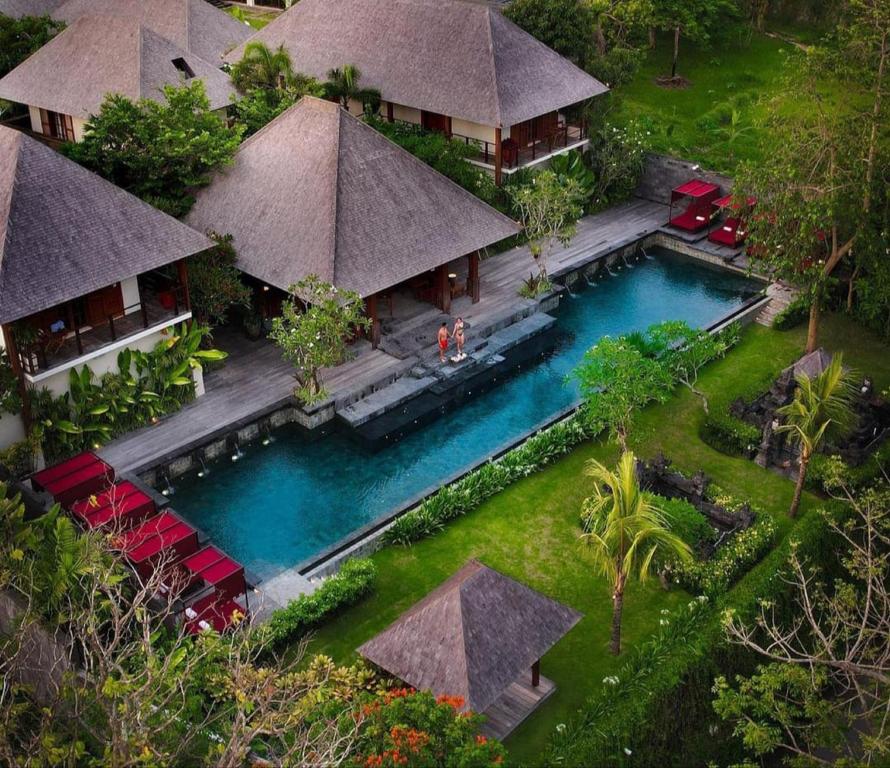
[581,451,692,656]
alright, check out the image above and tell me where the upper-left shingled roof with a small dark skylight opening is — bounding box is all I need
[0,16,234,119]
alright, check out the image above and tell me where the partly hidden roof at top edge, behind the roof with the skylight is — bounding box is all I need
[51,0,253,63]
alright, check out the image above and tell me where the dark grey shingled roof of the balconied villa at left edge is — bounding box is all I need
[0,126,212,323]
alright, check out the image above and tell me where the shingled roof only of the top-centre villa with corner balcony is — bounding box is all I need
[226,0,607,126]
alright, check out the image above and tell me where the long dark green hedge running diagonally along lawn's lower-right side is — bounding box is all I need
[543,504,838,768]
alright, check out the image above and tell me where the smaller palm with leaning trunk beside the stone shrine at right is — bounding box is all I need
[776,354,855,517]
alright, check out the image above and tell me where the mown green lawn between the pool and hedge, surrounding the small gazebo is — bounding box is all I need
[309,316,890,765]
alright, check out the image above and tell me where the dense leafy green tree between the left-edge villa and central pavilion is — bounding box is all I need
[63,80,243,216]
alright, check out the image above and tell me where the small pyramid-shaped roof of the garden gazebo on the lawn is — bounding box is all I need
[358,560,581,712]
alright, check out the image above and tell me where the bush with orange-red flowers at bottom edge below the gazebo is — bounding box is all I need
[352,688,506,768]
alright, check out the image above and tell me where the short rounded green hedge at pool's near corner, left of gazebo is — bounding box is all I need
[258,560,377,648]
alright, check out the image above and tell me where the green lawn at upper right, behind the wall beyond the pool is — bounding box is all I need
[616,31,799,172]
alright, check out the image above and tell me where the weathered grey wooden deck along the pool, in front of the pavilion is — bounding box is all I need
[99,199,667,473]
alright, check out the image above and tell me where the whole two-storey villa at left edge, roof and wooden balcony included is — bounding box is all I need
[0,127,212,446]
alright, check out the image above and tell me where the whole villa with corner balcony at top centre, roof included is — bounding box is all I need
[226,0,607,183]
